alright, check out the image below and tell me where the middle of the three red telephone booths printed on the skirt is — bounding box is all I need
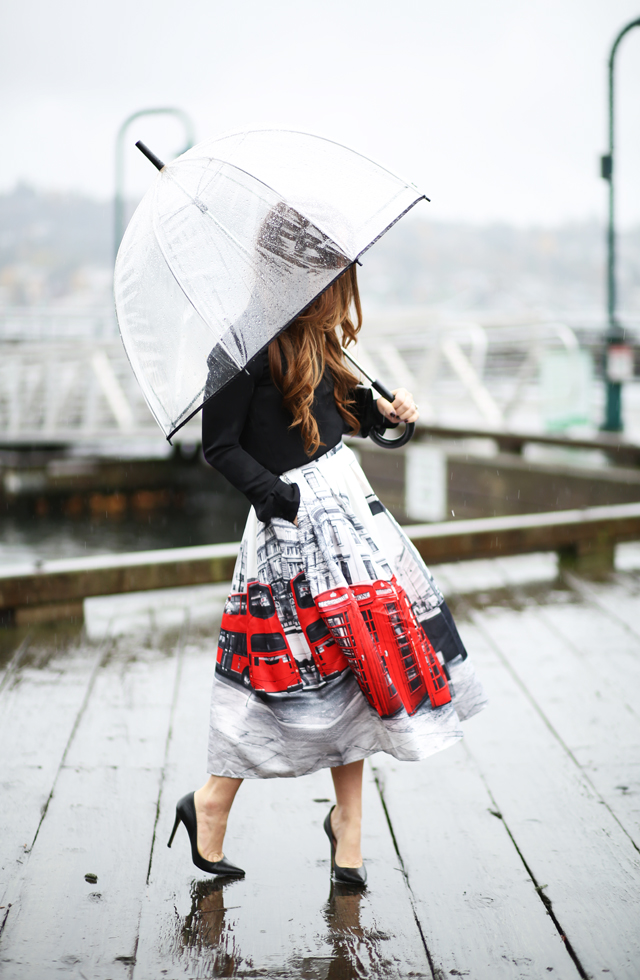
[354,580,427,715]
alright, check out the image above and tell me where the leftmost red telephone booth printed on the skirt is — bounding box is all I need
[316,587,402,718]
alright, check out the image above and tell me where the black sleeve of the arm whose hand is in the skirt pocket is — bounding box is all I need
[202,362,300,524]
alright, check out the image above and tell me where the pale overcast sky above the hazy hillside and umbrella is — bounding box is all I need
[0,0,640,225]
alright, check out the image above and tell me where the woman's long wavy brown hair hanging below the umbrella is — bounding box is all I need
[269,265,362,456]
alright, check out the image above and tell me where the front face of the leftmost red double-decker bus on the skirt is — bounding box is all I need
[247,582,302,694]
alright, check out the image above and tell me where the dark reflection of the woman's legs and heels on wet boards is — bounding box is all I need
[175,878,404,980]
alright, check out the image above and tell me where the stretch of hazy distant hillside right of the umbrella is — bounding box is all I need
[362,219,640,312]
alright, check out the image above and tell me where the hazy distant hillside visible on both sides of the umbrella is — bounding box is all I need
[0,185,640,314]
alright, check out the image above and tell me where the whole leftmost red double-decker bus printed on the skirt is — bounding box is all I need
[216,582,302,694]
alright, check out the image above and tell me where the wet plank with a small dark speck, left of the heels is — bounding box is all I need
[2,637,177,980]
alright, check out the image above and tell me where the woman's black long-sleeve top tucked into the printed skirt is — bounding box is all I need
[202,350,392,523]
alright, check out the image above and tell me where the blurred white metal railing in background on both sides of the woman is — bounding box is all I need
[0,310,640,444]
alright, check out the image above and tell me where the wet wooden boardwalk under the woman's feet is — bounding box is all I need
[0,556,640,980]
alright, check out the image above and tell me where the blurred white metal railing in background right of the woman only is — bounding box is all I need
[359,309,640,431]
